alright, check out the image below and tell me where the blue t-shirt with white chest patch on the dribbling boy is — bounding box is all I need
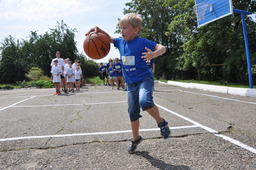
[114,37,157,84]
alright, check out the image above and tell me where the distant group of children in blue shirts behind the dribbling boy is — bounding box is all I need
[98,58,125,90]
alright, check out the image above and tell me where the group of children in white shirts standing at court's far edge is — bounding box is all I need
[51,51,83,95]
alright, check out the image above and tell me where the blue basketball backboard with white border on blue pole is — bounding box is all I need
[194,0,233,27]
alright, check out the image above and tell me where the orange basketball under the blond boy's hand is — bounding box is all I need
[84,33,110,60]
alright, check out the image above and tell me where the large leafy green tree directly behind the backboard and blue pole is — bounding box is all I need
[166,0,255,82]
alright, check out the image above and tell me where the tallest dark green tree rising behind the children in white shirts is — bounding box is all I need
[29,21,77,76]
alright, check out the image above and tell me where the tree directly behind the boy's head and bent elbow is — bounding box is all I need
[124,0,175,78]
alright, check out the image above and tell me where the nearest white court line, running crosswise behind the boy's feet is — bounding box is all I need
[0,125,198,142]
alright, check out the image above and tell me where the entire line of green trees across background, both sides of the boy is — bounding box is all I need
[0,0,256,84]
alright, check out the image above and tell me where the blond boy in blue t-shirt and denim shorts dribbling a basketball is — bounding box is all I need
[86,13,170,154]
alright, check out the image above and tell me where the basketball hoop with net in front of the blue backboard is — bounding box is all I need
[194,3,213,21]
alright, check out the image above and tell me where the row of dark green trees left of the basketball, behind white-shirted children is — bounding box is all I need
[0,21,98,83]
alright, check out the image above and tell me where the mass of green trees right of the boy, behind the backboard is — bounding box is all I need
[124,0,256,84]
